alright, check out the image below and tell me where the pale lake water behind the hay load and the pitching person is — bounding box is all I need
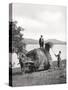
[26,44,66,60]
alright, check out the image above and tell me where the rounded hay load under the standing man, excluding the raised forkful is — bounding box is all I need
[26,48,50,70]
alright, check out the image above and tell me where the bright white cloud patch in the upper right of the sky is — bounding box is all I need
[37,11,62,23]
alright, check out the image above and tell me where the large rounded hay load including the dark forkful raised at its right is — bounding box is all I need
[26,42,52,70]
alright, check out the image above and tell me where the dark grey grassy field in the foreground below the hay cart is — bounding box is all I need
[12,60,66,87]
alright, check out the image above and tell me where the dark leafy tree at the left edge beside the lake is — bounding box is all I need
[9,21,25,52]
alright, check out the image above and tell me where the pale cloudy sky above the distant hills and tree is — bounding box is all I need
[12,3,66,41]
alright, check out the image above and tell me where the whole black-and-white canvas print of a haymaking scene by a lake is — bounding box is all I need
[9,3,67,87]
